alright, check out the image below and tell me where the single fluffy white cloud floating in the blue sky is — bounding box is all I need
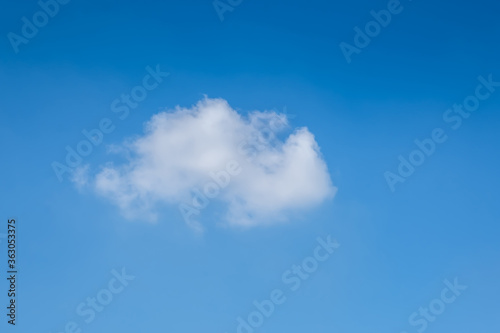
[91,98,336,229]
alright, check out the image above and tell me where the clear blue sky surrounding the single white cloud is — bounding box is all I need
[0,0,500,333]
